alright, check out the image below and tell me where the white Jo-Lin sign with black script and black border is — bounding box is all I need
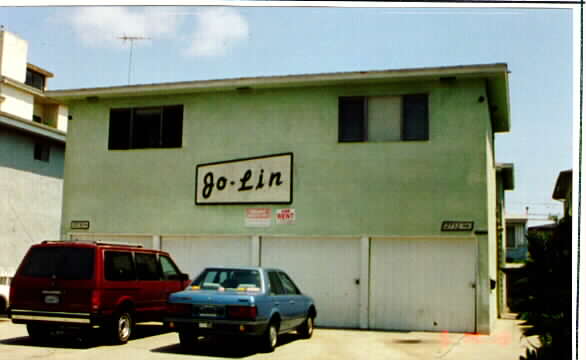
[195,153,293,205]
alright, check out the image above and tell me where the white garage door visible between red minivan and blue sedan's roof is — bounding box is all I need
[161,236,252,279]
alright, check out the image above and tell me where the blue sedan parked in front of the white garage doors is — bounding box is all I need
[165,267,317,351]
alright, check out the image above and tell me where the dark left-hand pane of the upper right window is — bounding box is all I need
[338,96,366,142]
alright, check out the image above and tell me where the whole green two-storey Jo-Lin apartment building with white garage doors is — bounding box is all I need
[50,64,510,333]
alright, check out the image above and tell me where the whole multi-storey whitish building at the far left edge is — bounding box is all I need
[0,30,67,283]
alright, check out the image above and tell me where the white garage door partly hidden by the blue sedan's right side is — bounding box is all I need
[261,237,360,328]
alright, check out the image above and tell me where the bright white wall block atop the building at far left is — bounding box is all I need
[0,31,28,83]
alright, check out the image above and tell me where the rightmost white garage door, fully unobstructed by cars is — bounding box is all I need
[369,238,476,332]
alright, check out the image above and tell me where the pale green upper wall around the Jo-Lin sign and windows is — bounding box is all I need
[62,81,494,240]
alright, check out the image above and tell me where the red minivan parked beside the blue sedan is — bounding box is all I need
[9,241,189,344]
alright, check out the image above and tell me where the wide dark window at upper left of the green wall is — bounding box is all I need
[108,105,183,150]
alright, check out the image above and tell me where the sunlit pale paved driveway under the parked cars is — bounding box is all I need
[0,318,527,360]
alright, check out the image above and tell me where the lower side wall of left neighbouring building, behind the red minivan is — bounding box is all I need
[0,127,65,276]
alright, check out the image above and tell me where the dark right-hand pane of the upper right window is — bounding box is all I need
[403,94,429,140]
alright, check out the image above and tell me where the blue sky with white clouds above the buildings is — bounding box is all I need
[0,1,579,225]
